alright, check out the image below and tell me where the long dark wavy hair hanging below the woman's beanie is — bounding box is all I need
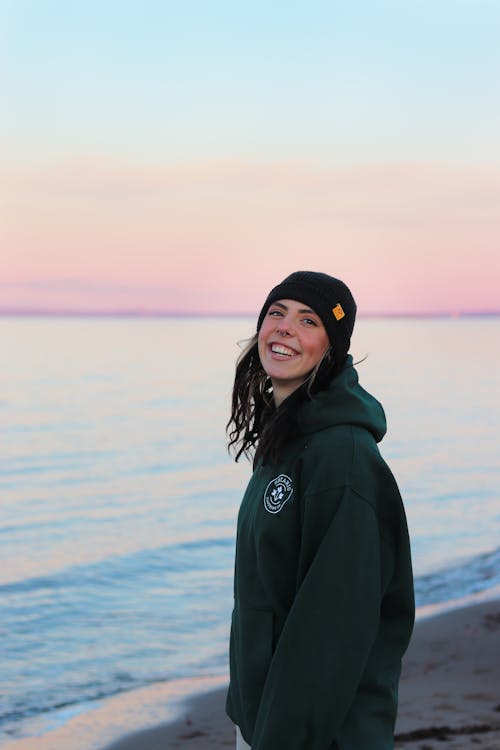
[226,334,344,463]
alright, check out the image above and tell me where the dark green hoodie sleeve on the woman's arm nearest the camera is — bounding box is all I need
[252,488,382,750]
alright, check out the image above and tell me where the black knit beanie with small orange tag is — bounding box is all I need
[257,271,356,362]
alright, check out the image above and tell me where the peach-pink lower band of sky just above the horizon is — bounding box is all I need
[0,158,500,313]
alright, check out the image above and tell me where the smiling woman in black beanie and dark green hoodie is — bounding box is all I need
[226,271,414,750]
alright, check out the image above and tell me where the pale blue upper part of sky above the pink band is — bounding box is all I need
[0,0,500,164]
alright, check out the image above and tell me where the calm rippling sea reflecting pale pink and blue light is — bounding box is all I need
[0,318,500,743]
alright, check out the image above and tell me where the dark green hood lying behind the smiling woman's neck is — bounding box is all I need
[298,355,387,443]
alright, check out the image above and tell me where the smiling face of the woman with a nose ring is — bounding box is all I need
[258,299,330,406]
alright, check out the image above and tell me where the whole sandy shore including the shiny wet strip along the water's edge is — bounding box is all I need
[0,599,500,750]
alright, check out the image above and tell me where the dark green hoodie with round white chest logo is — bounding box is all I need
[226,357,414,750]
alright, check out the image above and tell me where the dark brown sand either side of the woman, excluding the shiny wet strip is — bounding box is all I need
[102,601,500,750]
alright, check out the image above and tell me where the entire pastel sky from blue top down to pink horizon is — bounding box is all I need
[0,0,500,314]
